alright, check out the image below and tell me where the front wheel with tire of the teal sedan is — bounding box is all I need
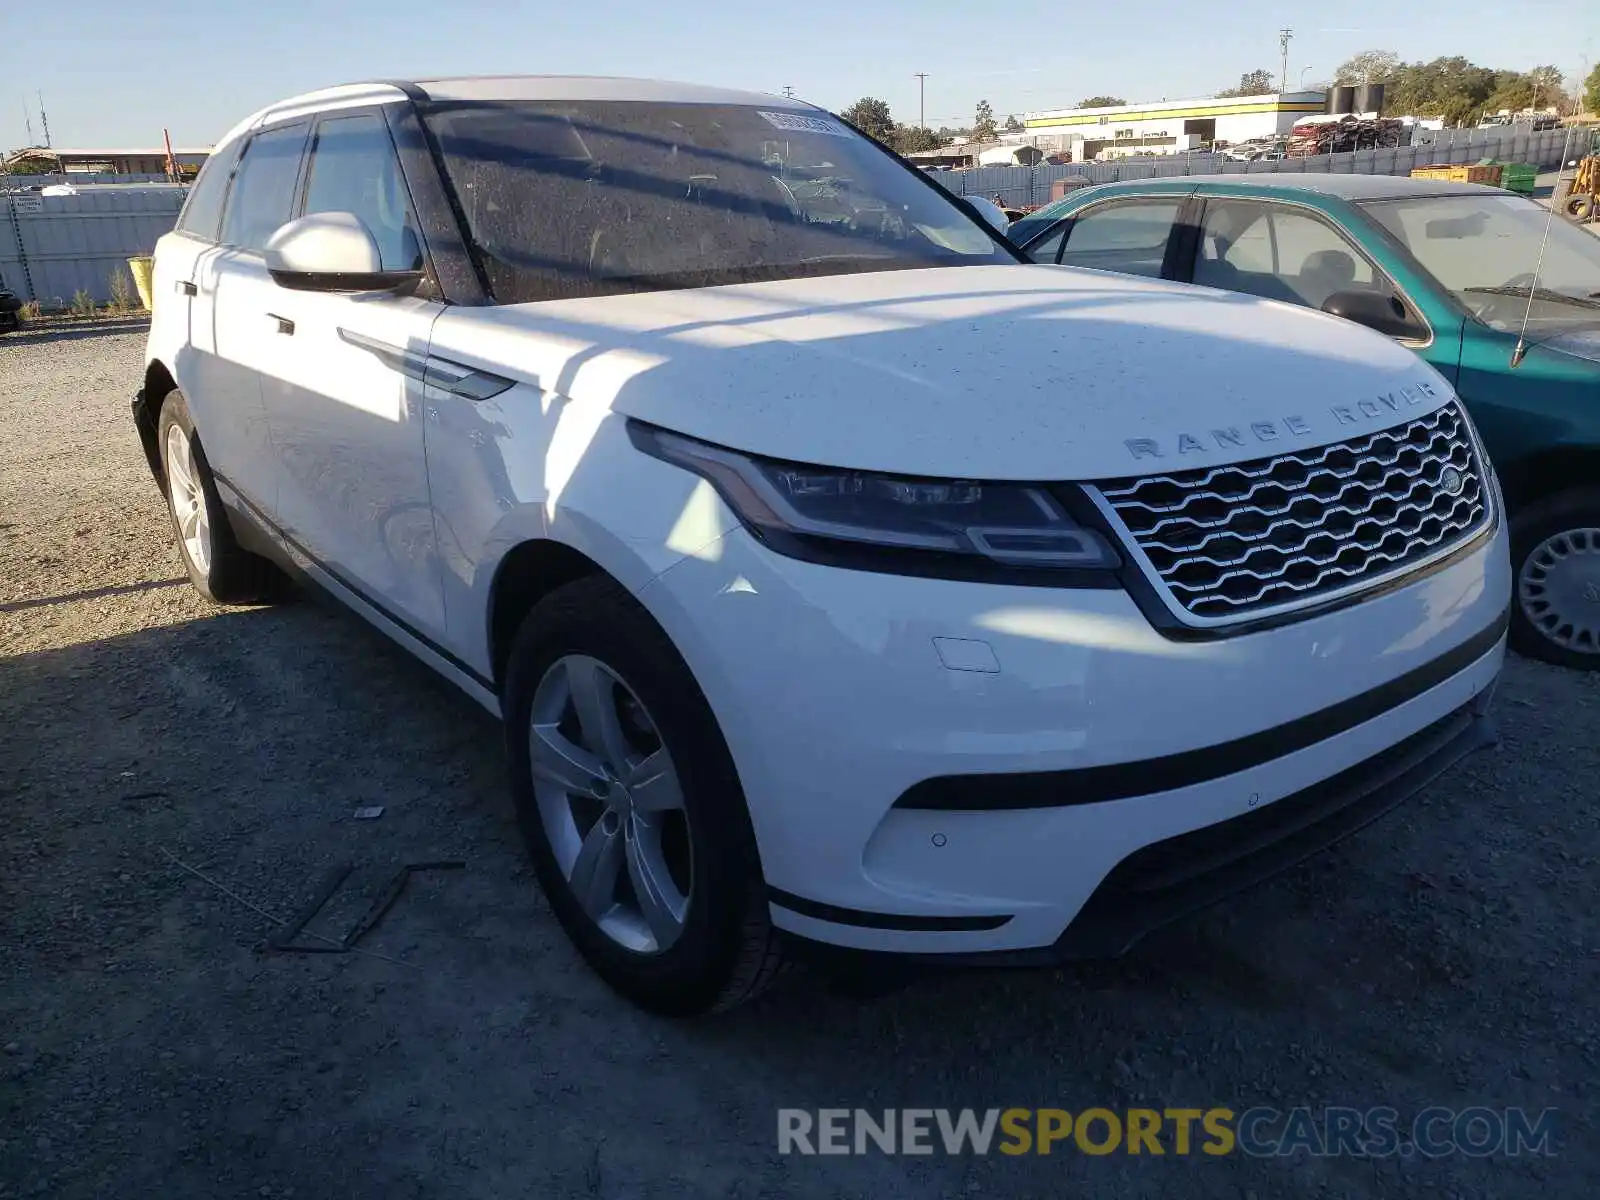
[1510,488,1600,670]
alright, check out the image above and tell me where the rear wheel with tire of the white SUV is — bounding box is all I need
[155,389,278,605]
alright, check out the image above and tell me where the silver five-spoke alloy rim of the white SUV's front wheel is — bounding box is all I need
[528,654,694,954]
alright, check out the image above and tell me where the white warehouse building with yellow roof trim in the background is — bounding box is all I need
[1022,91,1326,162]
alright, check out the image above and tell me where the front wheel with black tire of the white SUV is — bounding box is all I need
[502,576,782,1016]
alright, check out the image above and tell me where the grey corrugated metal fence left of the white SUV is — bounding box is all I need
[0,187,184,309]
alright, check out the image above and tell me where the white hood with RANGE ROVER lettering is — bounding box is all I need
[464,266,1451,480]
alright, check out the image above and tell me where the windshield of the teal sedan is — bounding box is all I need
[1363,190,1600,330]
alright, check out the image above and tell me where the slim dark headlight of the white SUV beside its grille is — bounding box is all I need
[630,422,1122,587]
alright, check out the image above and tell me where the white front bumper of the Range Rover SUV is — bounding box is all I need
[642,528,1510,958]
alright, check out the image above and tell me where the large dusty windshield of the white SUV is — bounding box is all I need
[426,101,1016,304]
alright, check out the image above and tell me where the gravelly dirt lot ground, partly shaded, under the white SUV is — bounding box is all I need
[0,328,1600,1200]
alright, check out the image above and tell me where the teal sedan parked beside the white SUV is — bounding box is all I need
[1008,174,1600,670]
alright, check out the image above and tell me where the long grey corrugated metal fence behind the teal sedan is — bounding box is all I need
[931,130,1566,206]
